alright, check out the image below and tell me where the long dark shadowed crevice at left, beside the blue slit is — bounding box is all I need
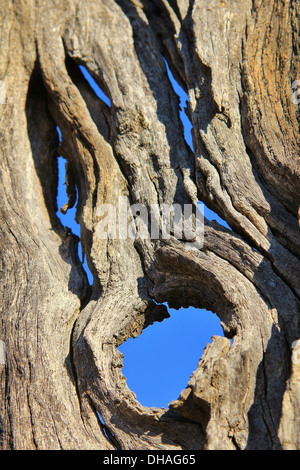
[25,64,89,299]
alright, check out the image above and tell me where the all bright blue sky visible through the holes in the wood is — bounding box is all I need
[57,64,228,407]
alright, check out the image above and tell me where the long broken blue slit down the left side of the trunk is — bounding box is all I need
[56,126,93,284]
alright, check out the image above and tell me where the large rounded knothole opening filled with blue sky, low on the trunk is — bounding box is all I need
[118,307,224,408]
